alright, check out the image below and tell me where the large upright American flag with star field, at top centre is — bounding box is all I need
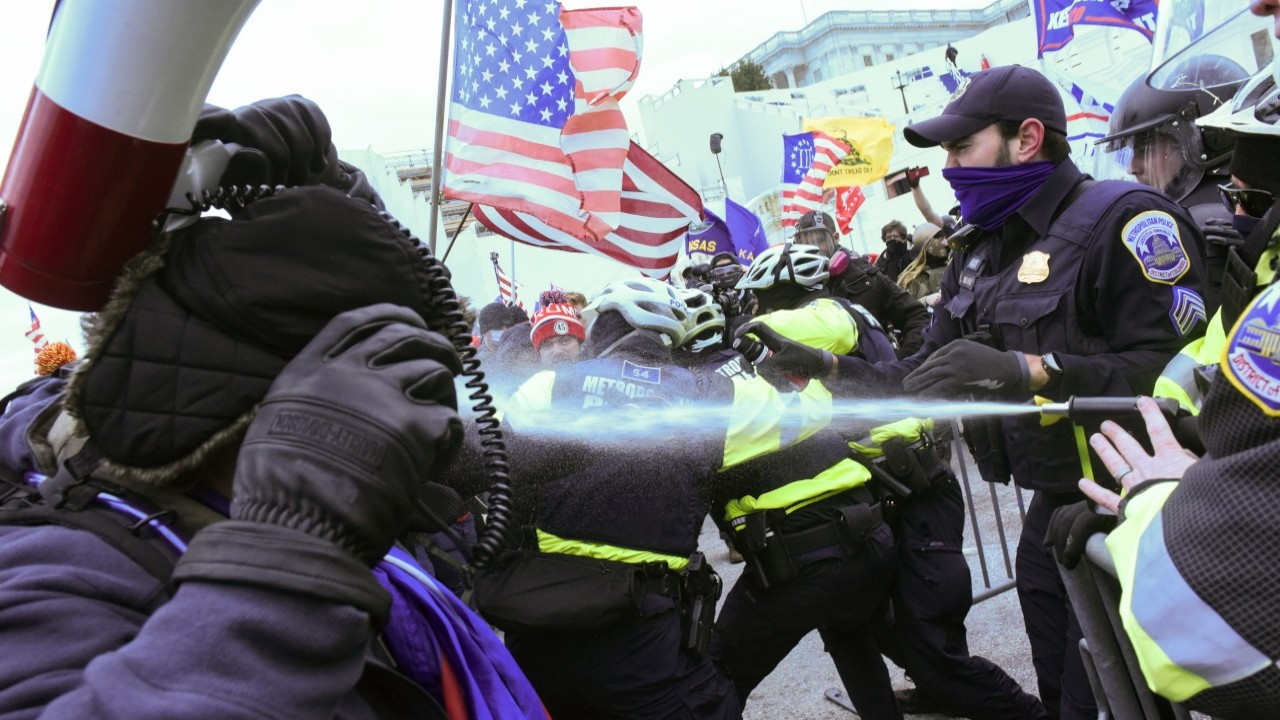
[444,0,641,240]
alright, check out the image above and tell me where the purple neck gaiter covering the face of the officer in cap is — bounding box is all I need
[942,160,1057,231]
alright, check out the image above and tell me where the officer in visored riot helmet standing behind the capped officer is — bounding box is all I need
[1098,50,1248,308]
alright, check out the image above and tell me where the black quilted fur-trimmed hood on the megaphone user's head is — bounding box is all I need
[64,186,434,488]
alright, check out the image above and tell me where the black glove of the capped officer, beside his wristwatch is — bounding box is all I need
[902,340,1030,400]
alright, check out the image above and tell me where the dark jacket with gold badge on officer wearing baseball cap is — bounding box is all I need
[841,160,1206,492]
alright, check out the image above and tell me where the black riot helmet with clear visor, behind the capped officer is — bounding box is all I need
[1098,55,1248,201]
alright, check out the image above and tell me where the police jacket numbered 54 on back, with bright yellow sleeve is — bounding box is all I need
[494,333,831,570]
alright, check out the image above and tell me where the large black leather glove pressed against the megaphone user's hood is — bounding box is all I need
[174,305,462,618]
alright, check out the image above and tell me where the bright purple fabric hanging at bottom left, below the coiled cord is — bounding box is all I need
[374,547,547,720]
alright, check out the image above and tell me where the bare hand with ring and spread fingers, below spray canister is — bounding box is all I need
[1079,397,1198,512]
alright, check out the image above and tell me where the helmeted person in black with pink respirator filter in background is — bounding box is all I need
[795,210,929,357]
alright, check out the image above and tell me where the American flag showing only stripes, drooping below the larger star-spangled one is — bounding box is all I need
[474,142,703,278]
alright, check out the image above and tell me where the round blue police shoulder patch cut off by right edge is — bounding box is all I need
[1221,284,1280,418]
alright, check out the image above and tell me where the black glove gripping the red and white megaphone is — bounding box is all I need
[191,95,383,209]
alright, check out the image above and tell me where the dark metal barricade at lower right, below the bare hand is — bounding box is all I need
[1059,533,1192,720]
